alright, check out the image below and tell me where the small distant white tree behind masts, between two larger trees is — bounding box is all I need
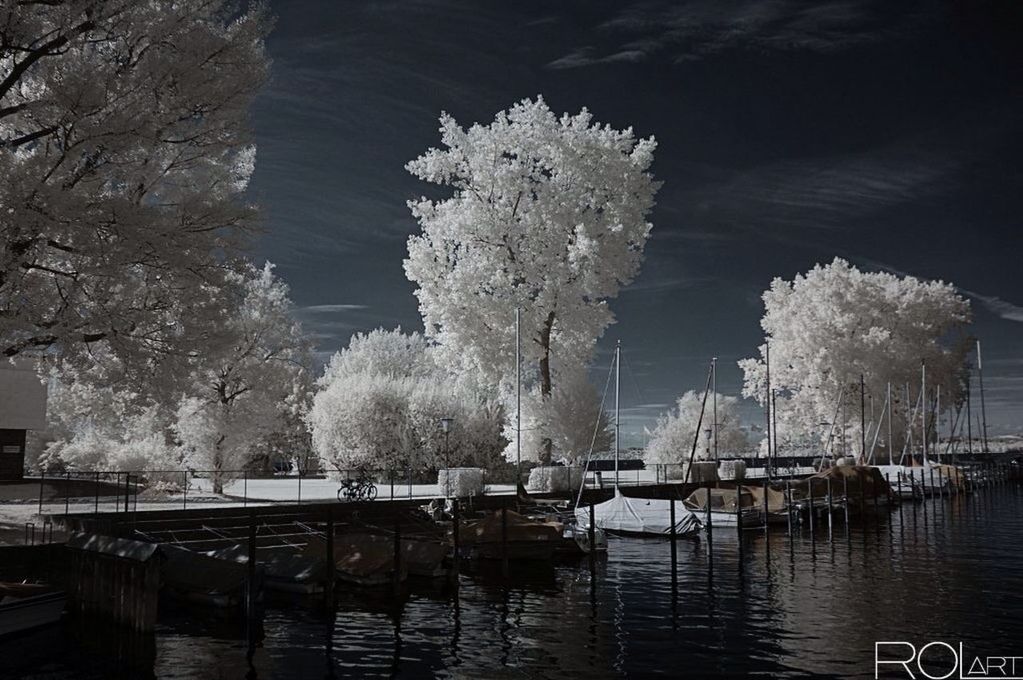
[646,390,749,464]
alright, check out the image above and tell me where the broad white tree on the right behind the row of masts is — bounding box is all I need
[739,258,970,454]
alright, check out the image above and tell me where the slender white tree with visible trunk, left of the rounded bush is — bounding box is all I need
[174,263,311,493]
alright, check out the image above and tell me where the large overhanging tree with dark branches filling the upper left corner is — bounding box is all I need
[0,0,268,366]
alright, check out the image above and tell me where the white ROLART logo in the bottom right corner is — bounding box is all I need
[874,640,1023,680]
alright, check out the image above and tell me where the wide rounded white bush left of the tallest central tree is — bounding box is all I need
[308,328,505,470]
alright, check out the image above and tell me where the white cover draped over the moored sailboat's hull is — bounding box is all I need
[576,489,702,536]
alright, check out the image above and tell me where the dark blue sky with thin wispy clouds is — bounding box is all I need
[251,0,1023,439]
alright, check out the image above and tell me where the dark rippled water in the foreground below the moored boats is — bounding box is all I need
[0,484,1023,679]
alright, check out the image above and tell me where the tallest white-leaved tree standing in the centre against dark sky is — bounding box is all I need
[405,97,659,460]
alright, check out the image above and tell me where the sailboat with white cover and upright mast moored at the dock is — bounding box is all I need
[575,342,702,538]
